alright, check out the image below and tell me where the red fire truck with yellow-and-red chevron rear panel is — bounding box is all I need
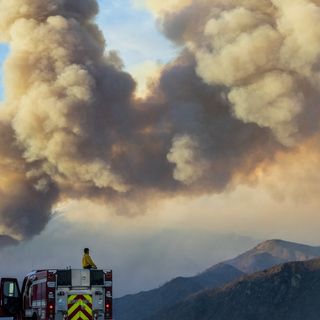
[0,269,112,320]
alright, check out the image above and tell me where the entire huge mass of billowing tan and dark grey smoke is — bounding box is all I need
[0,0,320,244]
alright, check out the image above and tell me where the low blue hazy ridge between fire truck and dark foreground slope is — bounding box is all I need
[114,264,243,320]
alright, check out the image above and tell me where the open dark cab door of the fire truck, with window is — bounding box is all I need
[0,278,21,317]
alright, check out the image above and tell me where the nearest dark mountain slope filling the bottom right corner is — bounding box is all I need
[147,259,320,320]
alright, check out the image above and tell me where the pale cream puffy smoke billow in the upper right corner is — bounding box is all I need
[159,0,320,146]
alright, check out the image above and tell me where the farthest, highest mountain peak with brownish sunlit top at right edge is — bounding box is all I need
[225,240,320,273]
